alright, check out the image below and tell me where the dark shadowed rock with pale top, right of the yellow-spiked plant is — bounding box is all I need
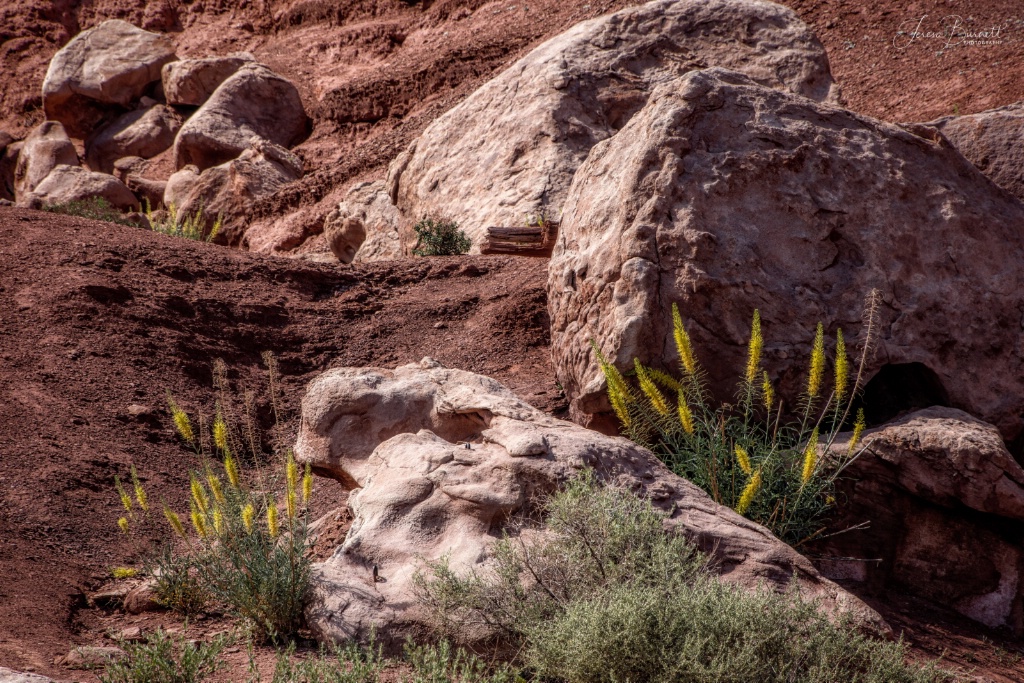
[822,408,1024,634]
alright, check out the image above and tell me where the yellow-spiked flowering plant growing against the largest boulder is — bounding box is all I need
[594,293,878,546]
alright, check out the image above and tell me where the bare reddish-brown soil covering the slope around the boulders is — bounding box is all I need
[0,0,1024,681]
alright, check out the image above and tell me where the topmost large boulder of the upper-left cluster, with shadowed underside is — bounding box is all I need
[43,19,177,137]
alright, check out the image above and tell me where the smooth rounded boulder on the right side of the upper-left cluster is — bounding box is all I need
[174,63,308,171]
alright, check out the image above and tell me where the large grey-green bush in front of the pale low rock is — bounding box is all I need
[417,476,947,683]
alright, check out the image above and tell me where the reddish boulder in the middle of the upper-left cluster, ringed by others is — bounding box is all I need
[85,104,181,173]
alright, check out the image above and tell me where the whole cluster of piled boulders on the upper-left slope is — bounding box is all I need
[0,19,309,243]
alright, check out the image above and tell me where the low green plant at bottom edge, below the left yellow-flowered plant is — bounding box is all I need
[99,629,227,683]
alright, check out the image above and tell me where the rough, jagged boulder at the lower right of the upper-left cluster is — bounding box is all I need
[164,137,302,245]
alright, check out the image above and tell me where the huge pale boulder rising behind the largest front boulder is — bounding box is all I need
[389,0,836,251]
